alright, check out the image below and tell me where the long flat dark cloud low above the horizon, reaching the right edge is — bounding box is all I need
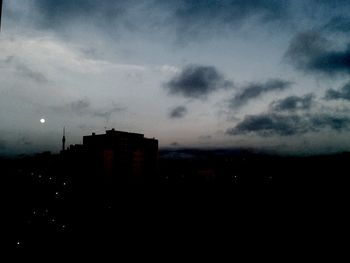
[227,113,350,136]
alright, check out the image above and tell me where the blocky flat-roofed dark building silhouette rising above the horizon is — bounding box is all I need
[63,129,158,183]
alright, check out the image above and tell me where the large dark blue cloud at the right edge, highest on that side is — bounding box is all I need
[285,32,350,75]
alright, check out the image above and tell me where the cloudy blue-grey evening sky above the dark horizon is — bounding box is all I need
[0,0,350,155]
